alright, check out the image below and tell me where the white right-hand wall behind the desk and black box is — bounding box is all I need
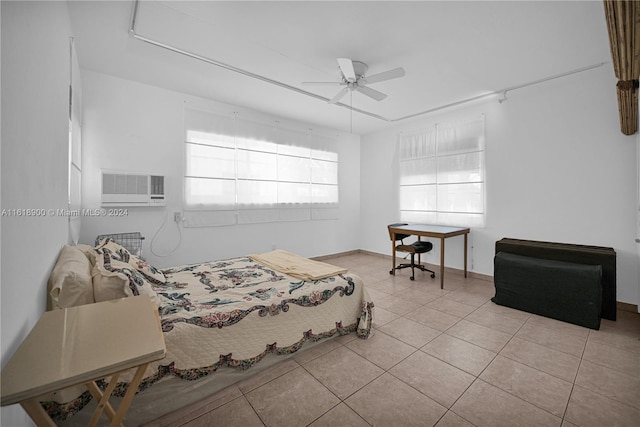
[361,65,638,304]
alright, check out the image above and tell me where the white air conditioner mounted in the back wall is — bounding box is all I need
[102,171,165,207]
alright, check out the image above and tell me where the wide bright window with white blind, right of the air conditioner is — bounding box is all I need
[184,109,338,227]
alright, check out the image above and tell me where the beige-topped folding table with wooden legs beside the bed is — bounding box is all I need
[0,295,166,426]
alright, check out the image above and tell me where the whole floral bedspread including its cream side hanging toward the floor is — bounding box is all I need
[43,257,373,420]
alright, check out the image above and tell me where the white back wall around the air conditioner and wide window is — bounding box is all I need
[80,70,360,266]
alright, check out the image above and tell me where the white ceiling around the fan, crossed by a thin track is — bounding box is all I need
[69,1,614,134]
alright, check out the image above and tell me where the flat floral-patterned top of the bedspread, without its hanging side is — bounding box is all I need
[154,258,366,332]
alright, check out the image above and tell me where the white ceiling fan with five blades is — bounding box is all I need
[302,58,405,104]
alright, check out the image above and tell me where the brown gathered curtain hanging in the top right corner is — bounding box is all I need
[604,0,640,135]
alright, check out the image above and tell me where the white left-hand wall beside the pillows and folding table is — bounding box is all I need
[0,1,71,426]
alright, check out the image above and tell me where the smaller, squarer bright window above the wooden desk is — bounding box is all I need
[399,113,485,227]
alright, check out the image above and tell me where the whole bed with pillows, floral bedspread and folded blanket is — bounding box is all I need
[42,238,373,423]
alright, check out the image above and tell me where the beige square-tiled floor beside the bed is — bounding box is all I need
[161,253,640,427]
